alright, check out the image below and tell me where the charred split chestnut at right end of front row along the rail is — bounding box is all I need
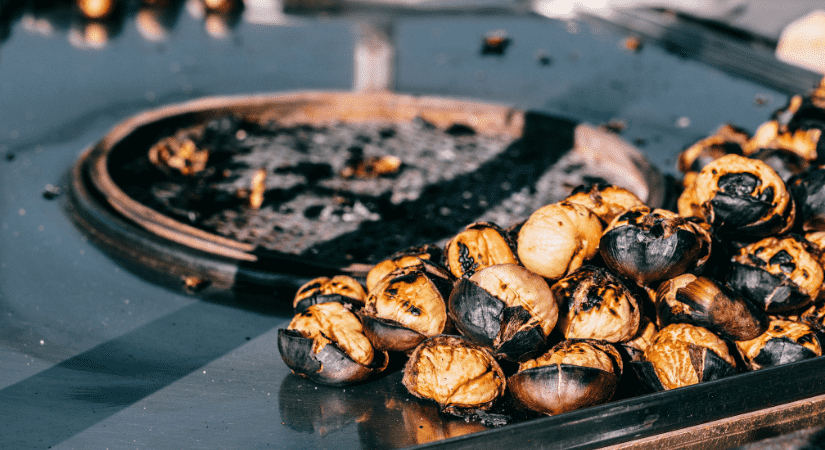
[736,318,822,370]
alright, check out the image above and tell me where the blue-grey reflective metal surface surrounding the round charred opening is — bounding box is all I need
[0,0,820,449]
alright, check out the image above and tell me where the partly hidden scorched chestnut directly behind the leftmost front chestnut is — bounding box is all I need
[292,275,367,313]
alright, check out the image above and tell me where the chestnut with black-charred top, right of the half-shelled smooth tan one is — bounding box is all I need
[550,266,642,343]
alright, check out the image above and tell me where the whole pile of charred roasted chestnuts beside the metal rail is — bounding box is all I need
[278,80,825,426]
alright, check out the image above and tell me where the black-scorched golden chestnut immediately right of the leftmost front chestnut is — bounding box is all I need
[359,259,455,352]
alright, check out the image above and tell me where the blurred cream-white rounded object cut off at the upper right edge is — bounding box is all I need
[776,10,825,74]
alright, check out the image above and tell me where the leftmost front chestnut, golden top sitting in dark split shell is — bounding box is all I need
[278,302,388,386]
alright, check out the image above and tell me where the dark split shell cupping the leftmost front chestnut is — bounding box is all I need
[278,329,389,386]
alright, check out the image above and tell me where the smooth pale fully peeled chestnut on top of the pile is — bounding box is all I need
[518,202,602,280]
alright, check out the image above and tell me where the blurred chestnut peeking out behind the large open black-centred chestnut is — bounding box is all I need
[677,124,750,187]
